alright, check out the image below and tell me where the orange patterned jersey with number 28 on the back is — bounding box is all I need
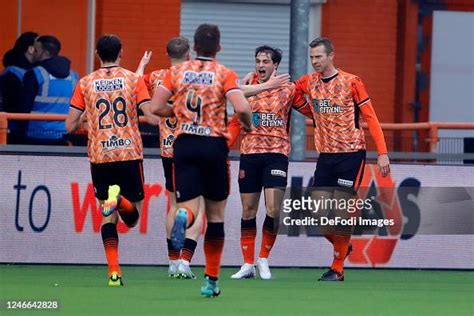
[71,67,150,163]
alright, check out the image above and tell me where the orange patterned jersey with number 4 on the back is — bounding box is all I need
[162,57,240,138]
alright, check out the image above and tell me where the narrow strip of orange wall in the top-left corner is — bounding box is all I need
[0,1,18,70]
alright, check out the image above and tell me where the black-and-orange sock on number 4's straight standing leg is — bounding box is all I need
[204,223,224,280]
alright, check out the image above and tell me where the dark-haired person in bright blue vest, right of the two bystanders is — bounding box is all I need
[23,35,79,145]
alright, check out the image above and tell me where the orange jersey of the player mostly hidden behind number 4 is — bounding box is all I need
[143,69,177,158]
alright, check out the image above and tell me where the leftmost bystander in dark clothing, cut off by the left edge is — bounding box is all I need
[0,32,38,144]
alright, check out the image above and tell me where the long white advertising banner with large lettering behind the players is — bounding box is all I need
[0,154,474,269]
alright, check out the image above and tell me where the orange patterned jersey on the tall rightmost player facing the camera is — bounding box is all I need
[296,70,370,153]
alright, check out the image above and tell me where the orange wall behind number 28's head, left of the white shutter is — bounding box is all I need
[96,0,181,72]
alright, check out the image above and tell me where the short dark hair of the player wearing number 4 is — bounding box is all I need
[194,24,221,57]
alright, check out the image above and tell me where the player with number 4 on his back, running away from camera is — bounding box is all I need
[142,24,251,297]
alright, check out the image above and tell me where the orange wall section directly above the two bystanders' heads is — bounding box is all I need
[19,0,87,75]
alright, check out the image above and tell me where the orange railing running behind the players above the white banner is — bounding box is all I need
[0,112,474,164]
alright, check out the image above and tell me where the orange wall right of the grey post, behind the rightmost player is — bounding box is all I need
[321,0,397,122]
